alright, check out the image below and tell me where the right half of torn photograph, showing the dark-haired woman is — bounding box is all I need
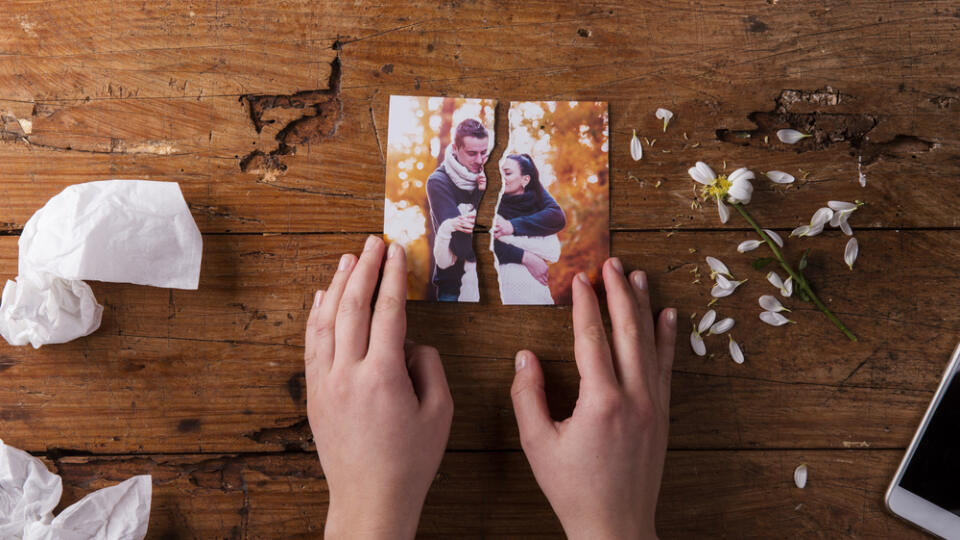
[490,101,610,305]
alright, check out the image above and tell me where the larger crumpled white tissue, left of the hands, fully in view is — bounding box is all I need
[0,180,203,348]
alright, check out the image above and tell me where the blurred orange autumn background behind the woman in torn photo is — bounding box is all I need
[501,101,610,305]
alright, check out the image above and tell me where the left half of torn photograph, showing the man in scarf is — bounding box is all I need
[383,96,497,302]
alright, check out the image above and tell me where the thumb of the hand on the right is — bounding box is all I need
[510,351,557,452]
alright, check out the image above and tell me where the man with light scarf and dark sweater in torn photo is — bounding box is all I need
[427,118,490,302]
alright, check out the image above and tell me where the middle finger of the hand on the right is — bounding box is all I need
[603,257,656,388]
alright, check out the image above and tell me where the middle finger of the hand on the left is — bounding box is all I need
[334,235,383,362]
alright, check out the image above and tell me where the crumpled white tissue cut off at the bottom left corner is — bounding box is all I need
[0,440,153,540]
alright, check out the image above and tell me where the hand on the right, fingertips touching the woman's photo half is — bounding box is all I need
[511,258,677,539]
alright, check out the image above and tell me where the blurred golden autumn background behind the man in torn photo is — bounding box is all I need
[383,96,496,300]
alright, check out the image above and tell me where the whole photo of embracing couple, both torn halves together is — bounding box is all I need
[384,96,609,305]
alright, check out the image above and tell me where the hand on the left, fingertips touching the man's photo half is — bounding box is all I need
[304,236,453,538]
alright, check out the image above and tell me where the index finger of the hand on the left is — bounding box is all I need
[369,243,407,365]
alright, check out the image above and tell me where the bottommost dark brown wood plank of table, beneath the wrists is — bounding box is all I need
[35,450,923,538]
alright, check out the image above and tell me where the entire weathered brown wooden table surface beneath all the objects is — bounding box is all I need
[0,0,960,538]
